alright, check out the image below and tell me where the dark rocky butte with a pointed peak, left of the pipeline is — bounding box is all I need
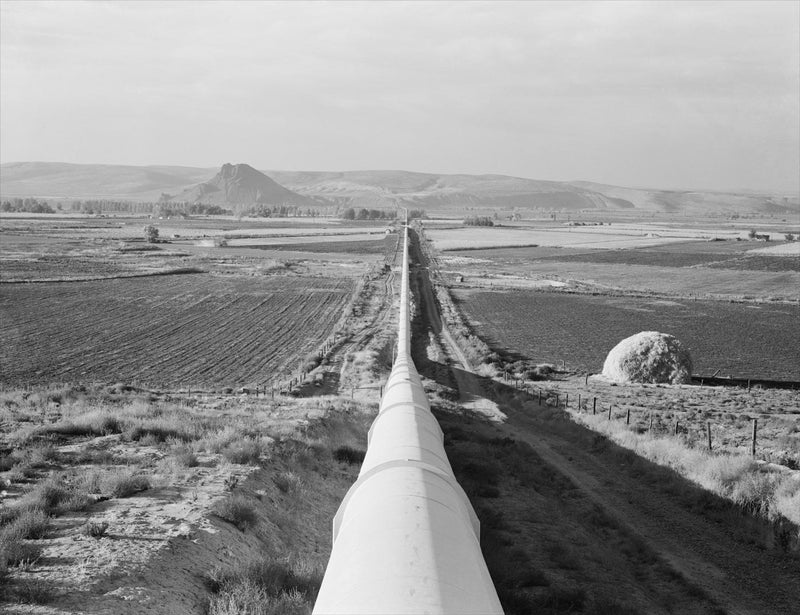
[171,164,319,206]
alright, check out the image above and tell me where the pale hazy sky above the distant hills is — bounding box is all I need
[0,0,800,192]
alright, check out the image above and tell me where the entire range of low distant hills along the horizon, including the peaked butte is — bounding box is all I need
[0,162,800,215]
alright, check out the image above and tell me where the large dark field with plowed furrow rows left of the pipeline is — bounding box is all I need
[0,274,354,387]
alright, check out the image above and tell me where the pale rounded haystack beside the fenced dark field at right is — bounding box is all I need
[603,331,692,384]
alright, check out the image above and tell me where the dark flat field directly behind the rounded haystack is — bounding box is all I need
[454,290,800,381]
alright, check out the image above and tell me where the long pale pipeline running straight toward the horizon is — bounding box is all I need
[313,227,503,615]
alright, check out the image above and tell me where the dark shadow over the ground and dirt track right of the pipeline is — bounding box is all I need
[406,226,800,615]
